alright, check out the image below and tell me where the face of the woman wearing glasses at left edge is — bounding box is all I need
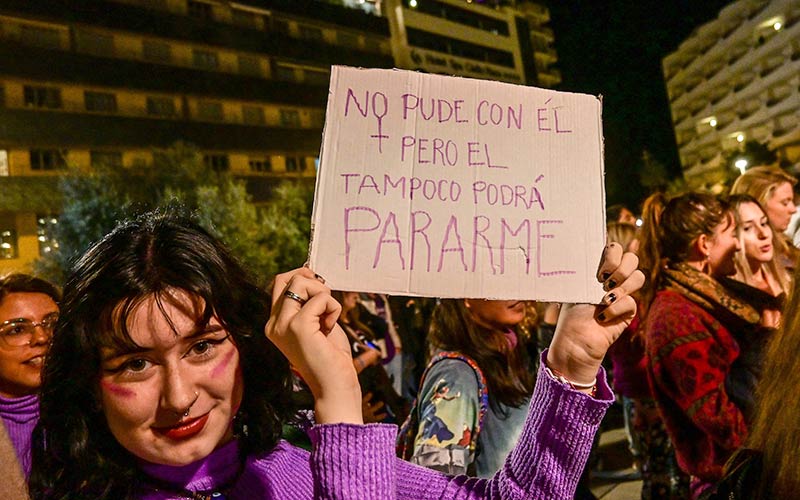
[0,292,58,398]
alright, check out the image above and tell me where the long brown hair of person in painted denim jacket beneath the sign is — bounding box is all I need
[428,299,535,410]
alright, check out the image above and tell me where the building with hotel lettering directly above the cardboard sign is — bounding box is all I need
[381,0,561,87]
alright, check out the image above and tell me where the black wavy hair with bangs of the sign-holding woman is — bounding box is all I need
[30,208,293,500]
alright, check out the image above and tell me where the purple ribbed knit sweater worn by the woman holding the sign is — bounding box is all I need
[140,360,613,500]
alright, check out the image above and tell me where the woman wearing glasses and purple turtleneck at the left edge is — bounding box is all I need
[0,274,60,476]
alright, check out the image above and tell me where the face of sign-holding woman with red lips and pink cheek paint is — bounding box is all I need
[100,290,243,465]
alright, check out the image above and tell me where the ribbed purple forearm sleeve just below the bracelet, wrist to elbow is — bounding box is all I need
[504,351,614,499]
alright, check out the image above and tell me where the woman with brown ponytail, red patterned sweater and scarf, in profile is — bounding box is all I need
[640,193,760,498]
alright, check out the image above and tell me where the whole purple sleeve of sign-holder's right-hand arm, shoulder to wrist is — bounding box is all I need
[396,351,614,500]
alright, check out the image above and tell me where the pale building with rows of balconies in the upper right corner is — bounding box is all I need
[663,0,800,187]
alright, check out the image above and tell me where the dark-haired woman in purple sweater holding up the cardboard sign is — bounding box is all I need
[31,208,643,500]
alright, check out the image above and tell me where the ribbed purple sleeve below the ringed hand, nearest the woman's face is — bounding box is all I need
[308,424,397,500]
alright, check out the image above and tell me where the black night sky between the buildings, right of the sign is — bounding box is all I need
[545,0,730,209]
